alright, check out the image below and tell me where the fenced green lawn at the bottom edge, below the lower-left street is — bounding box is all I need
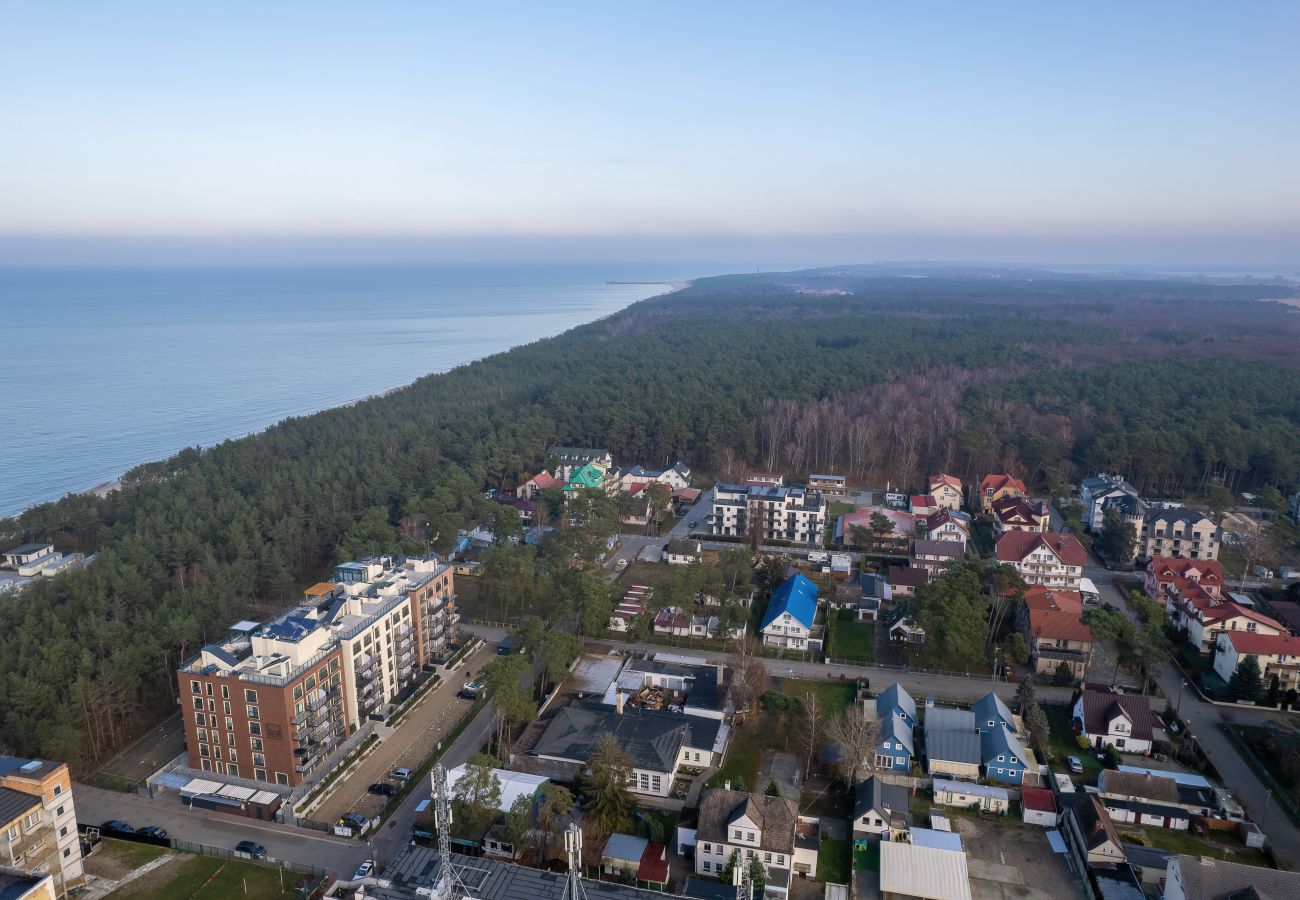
[108,856,306,900]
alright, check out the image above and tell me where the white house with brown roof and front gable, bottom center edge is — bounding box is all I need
[696,788,816,897]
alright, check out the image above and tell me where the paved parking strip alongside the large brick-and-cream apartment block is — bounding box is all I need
[307,645,497,825]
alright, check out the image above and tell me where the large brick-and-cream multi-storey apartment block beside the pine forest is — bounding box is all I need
[177,557,459,787]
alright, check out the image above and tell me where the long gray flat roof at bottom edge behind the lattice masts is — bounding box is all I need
[365,844,686,900]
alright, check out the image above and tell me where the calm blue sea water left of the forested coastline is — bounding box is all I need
[0,264,722,515]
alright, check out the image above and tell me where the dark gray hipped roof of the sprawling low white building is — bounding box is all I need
[532,705,722,773]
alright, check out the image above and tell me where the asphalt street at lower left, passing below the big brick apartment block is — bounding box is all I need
[73,784,369,877]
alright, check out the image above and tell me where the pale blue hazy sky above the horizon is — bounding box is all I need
[0,0,1300,268]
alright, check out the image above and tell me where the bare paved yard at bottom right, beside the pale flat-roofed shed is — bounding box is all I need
[952,815,1086,900]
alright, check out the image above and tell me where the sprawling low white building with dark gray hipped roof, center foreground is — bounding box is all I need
[529,692,728,797]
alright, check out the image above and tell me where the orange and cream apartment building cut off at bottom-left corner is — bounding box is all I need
[0,756,86,897]
